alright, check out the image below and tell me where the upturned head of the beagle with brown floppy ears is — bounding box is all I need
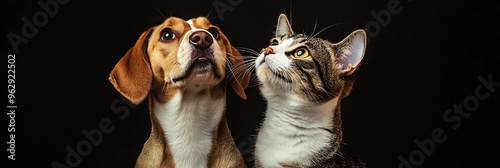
[109,17,250,104]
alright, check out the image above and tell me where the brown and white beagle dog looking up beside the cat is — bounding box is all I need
[109,17,250,168]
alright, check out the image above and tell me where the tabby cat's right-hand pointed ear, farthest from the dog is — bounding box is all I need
[333,29,366,76]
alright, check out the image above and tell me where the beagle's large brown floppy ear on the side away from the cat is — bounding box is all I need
[109,28,154,105]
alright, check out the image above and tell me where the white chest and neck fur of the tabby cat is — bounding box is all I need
[255,90,338,168]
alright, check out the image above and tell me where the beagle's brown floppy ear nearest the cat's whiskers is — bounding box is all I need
[227,46,251,100]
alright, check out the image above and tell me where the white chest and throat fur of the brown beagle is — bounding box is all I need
[154,92,226,168]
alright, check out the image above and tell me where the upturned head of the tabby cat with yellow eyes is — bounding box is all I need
[255,14,366,103]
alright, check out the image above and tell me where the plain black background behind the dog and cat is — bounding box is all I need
[0,0,500,167]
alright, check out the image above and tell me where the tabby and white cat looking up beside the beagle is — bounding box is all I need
[254,14,367,168]
